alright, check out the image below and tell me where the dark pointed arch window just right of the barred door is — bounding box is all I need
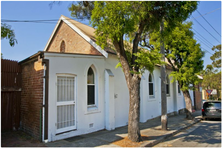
[87,67,96,106]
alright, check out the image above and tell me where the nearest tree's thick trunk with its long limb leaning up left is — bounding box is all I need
[114,41,141,142]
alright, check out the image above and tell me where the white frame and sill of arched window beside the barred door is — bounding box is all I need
[86,65,98,111]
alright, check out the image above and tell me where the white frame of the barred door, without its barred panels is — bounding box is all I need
[55,74,77,134]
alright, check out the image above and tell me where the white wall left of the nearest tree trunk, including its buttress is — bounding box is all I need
[45,53,129,141]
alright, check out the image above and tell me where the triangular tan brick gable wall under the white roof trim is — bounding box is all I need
[47,22,102,55]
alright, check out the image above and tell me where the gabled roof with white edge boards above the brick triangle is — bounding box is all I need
[44,15,108,58]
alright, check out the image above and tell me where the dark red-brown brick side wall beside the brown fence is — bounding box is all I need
[21,61,43,140]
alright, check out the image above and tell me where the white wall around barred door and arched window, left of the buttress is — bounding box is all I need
[45,53,105,141]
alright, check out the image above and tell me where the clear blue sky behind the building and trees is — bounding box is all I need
[1,1,221,69]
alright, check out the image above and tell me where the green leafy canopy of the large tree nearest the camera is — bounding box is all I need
[91,1,197,72]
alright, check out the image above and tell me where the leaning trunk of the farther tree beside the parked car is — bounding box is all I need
[183,90,193,120]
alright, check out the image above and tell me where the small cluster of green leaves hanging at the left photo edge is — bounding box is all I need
[1,23,18,46]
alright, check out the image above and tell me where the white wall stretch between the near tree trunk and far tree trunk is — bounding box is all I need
[140,67,188,122]
